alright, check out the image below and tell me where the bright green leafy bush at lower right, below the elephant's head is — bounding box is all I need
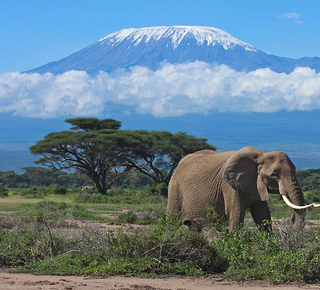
[212,229,320,283]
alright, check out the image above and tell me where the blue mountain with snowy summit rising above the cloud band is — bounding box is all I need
[27,26,320,75]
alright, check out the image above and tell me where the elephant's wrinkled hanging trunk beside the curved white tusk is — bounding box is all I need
[279,177,312,229]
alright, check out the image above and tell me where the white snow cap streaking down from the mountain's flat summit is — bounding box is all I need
[99,26,257,51]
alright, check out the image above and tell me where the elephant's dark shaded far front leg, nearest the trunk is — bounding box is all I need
[250,201,272,231]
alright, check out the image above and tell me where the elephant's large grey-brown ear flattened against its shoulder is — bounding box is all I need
[223,147,269,201]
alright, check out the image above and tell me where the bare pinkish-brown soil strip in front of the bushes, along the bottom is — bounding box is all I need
[0,271,320,290]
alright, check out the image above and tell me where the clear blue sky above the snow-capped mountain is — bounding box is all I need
[0,0,320,73]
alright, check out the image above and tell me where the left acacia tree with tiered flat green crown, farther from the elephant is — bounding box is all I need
[30,118,131,194]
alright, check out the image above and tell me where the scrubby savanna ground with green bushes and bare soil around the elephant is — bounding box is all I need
[0,189,320,290]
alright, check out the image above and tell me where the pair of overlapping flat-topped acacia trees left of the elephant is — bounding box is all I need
[30,118,215,194]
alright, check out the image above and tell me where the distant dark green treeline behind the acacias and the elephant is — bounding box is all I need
[0,167,320,193]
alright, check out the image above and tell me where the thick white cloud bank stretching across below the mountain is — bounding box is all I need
[0,61,320,118]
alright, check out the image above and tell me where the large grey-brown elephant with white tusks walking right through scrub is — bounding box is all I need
[167,147,320,231]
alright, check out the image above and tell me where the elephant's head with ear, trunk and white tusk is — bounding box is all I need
[224,147,313,229]
